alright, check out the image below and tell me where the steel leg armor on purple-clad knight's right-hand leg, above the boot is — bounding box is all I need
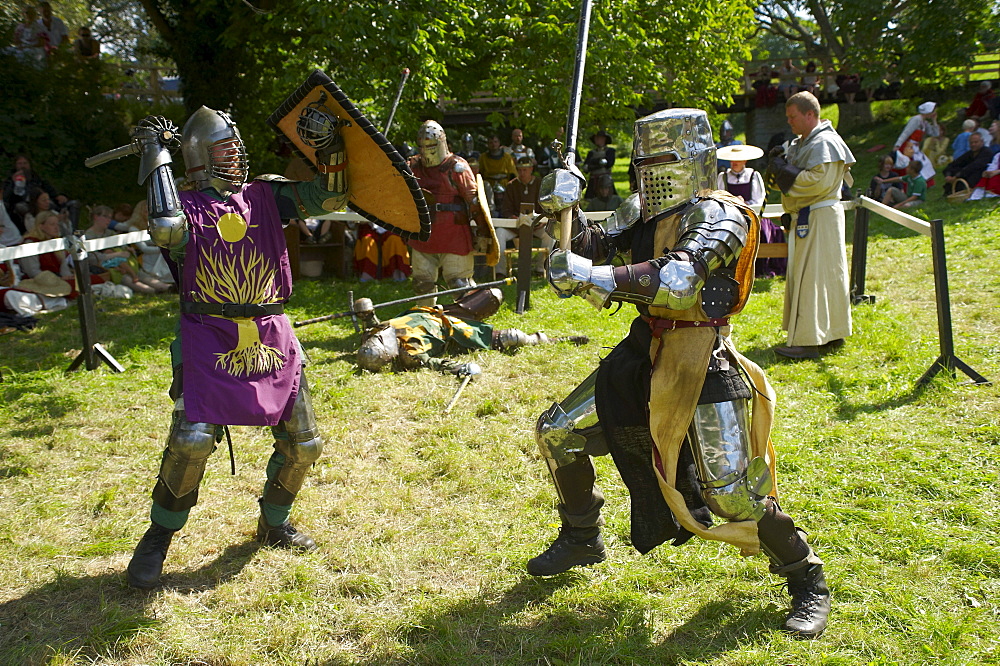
[264,372,323,506]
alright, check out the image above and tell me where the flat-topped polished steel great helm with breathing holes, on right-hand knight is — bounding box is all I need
[632,109,716,220]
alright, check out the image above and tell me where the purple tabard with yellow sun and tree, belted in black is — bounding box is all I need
[180,181,301,425]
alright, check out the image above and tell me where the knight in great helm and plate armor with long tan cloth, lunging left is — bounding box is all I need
[527,109,830,638]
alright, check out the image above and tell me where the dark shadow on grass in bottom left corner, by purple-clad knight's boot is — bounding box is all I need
[0,542,259,666]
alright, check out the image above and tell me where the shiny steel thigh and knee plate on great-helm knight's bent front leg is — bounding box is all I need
[535,370,608,467]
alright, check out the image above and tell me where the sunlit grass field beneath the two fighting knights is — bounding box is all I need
[0,101,1000,665]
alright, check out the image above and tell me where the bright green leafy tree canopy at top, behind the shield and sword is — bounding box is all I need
[135,0,753,171]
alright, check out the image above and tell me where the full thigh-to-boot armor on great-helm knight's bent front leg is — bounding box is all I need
[535,370,608,527]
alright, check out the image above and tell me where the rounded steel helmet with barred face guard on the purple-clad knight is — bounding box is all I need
[181,106,250,196]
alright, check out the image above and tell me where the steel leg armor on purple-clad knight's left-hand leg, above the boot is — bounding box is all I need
[153,409,216,511]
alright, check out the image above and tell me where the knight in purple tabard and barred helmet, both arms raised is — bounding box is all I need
[128,106,348,589]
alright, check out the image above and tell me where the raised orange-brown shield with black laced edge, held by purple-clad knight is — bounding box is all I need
[267,69,431,240]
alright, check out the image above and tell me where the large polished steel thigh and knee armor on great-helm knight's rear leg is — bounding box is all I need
[688,399,773,521]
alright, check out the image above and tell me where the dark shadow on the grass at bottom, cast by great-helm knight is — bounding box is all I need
[356,572,784,666]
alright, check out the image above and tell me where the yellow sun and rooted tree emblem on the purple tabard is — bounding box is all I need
[195,241,285,377]
